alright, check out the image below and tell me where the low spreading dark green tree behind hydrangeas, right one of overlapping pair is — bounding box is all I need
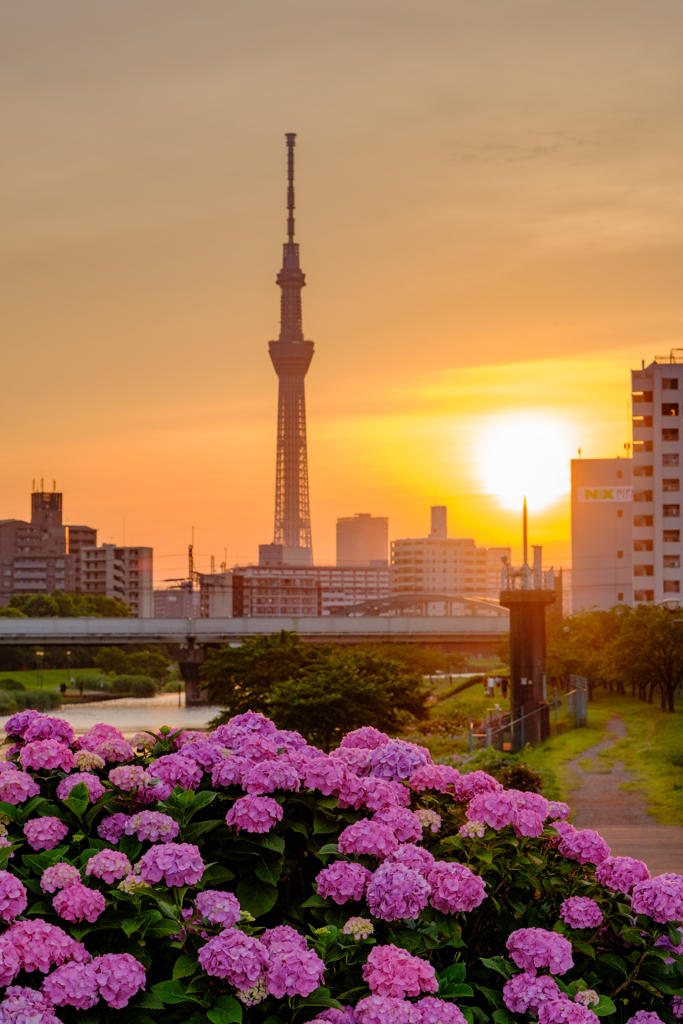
[267,649,428,749]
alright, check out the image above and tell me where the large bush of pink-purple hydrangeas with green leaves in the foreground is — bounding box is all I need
[0,711,683,1024]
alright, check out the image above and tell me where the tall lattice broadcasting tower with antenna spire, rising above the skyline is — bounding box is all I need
[268,133,313,562]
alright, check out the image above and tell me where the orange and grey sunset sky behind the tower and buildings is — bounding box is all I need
[0,0,683,586]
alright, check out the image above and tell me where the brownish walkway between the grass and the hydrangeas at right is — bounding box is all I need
[565,715,683,874]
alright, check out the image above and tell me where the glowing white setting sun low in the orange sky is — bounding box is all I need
[477,412,572,511]
